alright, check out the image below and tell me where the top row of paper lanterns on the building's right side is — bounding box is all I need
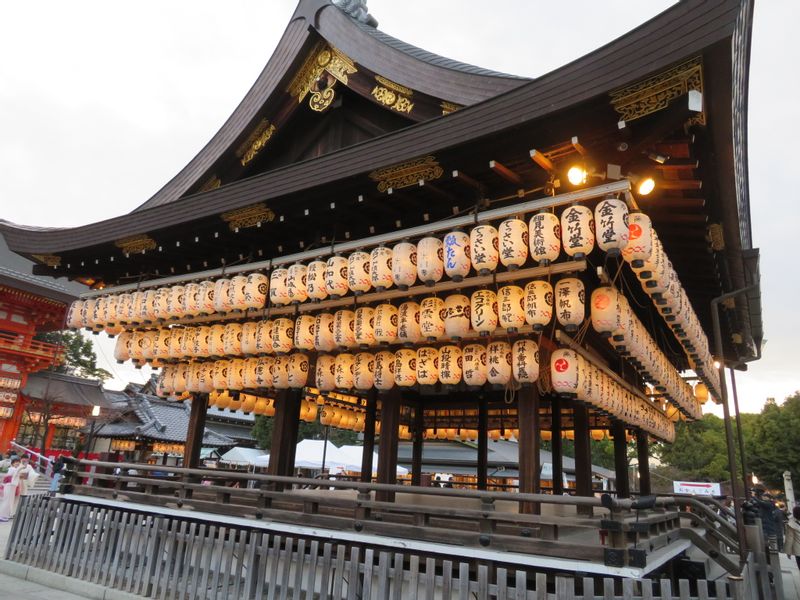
[622,213,719,394]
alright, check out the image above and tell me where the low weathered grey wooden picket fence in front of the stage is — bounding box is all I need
[6,496,745,600]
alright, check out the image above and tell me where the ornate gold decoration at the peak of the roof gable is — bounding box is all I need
[287,41,358,112]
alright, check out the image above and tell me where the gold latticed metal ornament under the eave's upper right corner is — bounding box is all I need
[609,56,706,125]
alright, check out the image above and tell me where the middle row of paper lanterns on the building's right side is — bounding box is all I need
[591,286,703,420]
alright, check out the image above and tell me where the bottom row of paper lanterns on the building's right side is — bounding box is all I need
[550,348,675,442]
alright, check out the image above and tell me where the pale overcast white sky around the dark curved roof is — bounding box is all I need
[0,0,800,412]
